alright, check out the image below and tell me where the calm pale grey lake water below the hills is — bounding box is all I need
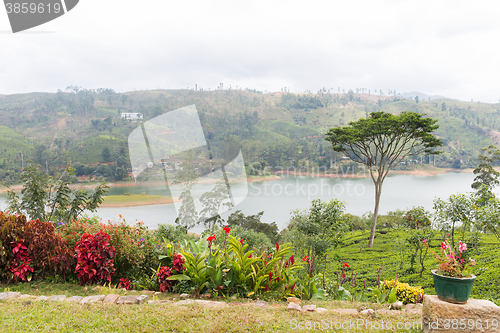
[0,173,484,231]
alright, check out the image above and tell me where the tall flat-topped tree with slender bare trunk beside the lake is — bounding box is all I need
[325,111,443,247]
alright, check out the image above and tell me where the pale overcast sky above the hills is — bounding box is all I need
[0,0,500,102]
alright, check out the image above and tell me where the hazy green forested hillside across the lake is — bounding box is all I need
[0,86,500,185]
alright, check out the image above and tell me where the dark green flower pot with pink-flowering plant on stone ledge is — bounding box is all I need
[423,238,476,304]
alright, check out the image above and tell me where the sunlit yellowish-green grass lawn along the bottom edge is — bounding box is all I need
[0,282,422,332]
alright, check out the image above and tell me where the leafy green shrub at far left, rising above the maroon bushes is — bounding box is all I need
[7,161,109,222]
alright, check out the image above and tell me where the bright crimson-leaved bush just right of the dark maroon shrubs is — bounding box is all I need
[75,231,116,285]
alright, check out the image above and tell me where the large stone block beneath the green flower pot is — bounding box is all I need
[422,295,500,333]
